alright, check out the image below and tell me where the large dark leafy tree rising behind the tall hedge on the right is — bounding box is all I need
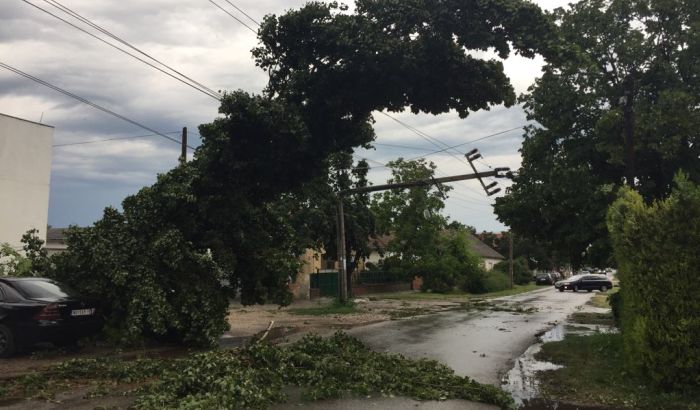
[495,0,700,266]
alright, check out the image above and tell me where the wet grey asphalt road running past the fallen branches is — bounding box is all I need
[348,287,593,385]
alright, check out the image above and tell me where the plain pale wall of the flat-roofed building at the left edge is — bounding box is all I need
[0,114,54,248]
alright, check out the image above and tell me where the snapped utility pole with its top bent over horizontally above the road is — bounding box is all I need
[337,167,510,303]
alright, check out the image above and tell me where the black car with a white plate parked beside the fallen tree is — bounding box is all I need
[0,277,102,357]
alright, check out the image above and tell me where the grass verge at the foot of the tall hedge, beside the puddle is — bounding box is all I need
[536,333,700,409]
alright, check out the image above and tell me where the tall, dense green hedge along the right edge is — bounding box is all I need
[608,175,700,390]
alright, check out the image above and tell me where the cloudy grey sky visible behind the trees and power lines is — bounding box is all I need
[0,0,567,230]
